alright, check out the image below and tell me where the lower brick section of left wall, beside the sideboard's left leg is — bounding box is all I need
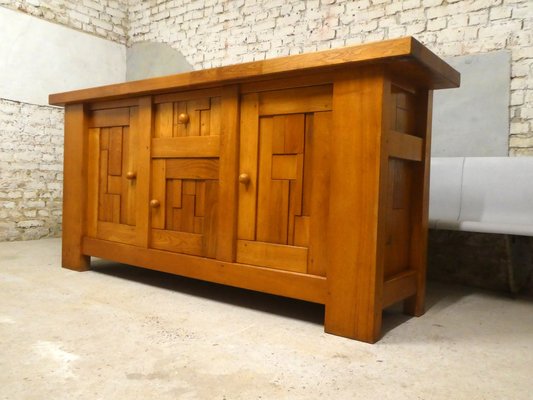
[0,99,63,241]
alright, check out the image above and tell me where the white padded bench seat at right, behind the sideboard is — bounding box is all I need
[429,157,533,236]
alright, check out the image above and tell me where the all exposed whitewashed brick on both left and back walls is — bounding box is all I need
[0,0,533,240]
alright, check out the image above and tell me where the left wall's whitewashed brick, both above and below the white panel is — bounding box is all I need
[0,0,128,241]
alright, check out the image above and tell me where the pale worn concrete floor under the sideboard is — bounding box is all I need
[0,239,533,400]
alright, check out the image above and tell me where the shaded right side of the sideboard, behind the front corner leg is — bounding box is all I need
[384,84,431,315]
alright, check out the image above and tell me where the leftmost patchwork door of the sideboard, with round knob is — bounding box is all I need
[87,107,138,244]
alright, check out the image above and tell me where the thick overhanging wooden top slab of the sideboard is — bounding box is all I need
[49,37,460,105]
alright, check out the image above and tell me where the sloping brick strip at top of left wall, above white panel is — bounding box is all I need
[0,0,128,43]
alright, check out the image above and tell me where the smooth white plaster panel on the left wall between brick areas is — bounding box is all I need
[0,7,126,105]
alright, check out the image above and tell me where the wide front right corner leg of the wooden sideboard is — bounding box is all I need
[325,66,390,343]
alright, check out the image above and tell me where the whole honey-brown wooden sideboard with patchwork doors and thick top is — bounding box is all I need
[50,38,460,342]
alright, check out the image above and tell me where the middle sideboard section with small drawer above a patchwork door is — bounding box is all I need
[150,89,221,258]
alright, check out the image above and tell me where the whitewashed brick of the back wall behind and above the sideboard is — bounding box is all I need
[128,0,533,155]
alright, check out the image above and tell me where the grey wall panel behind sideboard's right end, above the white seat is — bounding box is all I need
[431,51,511,157]
